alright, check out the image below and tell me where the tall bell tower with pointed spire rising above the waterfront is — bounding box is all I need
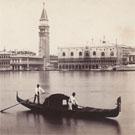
[39,3,50,69]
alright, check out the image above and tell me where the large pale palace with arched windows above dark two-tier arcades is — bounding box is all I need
[58,41,133,70]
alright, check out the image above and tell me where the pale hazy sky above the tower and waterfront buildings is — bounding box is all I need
[0,0,135,54]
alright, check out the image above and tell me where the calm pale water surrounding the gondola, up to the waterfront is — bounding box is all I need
[0,71,135,135]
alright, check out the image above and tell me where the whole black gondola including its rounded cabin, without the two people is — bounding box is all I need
[16,92,121,118]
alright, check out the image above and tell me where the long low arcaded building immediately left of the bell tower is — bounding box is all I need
[10,51,43,71]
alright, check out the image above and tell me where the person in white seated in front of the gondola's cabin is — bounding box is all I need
[68,92,78,110]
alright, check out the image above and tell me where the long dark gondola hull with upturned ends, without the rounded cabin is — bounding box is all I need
[16,94,121,117]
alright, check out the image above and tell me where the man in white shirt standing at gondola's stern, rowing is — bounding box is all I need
[33,84,45,104]
